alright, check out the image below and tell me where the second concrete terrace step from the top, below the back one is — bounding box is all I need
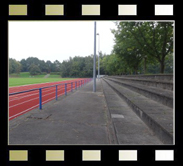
[106,77,173,108]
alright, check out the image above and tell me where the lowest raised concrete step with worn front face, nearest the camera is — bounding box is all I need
[103,79,173,144]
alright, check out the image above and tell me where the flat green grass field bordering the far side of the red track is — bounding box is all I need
[9,78,74,87]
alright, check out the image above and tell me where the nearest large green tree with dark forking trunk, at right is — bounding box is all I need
[112,21,174,73]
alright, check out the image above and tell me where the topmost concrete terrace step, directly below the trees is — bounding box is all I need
[110,76,173,91]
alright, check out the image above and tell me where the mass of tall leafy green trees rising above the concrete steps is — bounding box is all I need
[112,21,174,74]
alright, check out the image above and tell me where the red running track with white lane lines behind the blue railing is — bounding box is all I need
[9,79,91,120]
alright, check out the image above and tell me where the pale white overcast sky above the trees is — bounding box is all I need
[8,21,116,62]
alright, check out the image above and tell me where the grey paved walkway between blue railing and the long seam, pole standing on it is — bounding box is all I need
[9,80,116,145]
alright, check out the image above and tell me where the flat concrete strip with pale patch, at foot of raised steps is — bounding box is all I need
[102,81,163,145]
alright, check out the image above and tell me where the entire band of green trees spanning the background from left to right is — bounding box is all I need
[9,22,174,77]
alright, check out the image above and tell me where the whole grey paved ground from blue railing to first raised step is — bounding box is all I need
[9,79,162,145]
